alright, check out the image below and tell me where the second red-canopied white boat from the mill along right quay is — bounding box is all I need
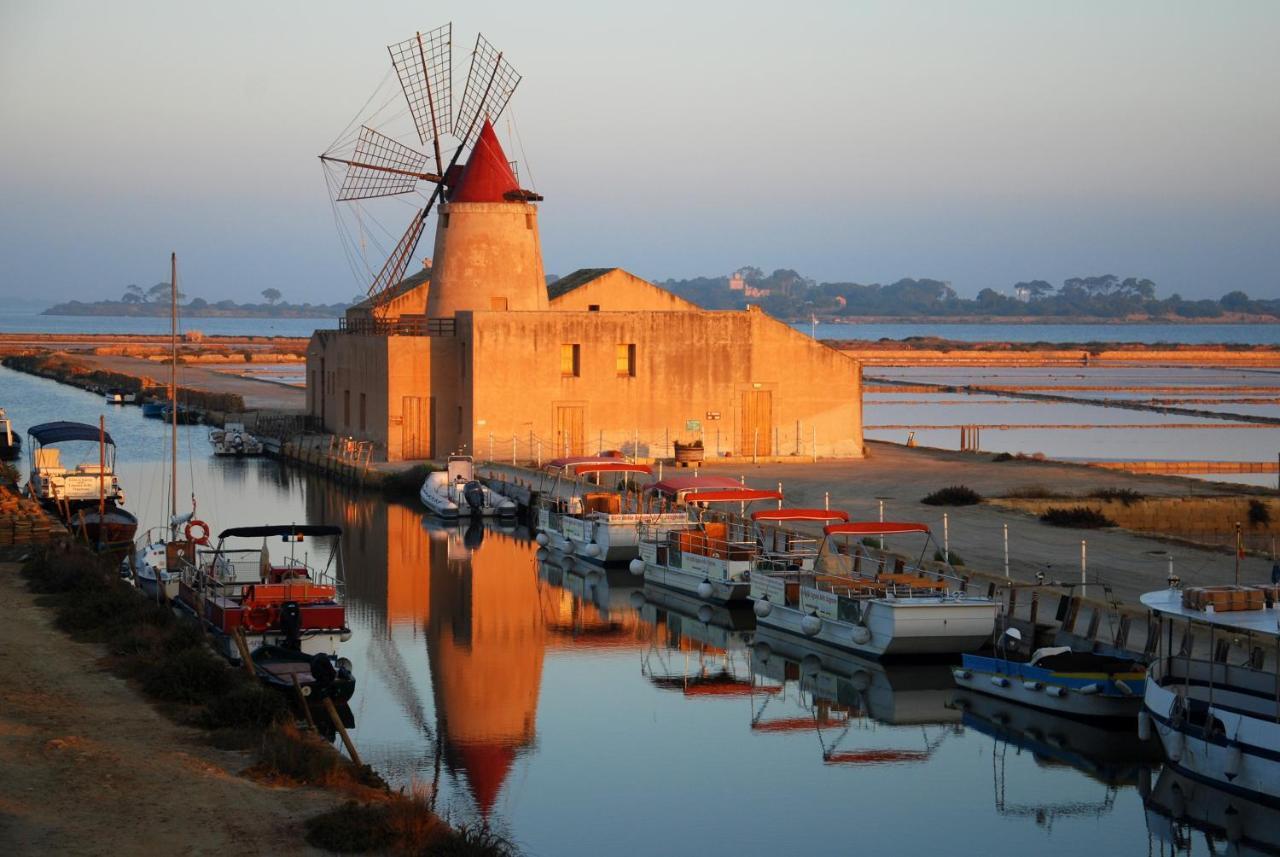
[630,476,782,604]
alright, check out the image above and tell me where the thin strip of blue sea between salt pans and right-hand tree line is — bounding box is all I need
[792,321,1280,345]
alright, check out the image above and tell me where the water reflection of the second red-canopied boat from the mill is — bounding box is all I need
[632,585,757,698]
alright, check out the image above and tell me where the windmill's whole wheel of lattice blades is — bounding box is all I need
[320,23,543,317]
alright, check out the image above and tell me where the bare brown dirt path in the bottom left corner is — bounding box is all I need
[0,563,338,857]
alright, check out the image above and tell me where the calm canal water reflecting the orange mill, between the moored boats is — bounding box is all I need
[0,370,1264,857]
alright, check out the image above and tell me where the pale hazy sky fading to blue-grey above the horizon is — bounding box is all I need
[0,0,1280,303]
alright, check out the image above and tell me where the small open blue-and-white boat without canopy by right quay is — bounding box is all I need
[952,628,1147,721]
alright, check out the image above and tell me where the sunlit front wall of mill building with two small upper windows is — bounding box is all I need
[458,305,863,458]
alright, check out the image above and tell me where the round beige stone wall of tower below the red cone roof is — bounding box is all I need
[426,202,547,318]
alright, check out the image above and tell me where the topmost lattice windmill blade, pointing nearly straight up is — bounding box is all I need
[387,23,453,173]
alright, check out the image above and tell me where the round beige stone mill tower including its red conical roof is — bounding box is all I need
[426,120,547,318]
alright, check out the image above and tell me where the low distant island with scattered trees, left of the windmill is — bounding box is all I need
[41,283,350,318]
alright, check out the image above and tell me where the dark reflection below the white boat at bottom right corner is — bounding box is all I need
[1143,765,1280,856]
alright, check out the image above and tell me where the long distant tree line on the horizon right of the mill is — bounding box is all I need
[663,267,1280,321]
